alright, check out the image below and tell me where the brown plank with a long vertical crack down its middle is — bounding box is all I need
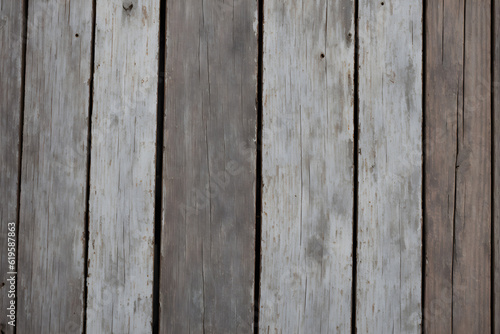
[424,1,491,333]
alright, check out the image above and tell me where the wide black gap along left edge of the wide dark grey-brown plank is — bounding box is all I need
[152,0,167,334]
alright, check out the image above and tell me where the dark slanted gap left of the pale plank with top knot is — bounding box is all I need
[82,0,97,333]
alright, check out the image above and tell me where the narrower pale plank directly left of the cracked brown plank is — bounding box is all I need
[356,0,423,333]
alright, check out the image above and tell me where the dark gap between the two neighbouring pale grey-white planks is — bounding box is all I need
[351,0,359,334]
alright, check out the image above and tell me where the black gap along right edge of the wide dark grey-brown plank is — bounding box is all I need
[254,0,264,334]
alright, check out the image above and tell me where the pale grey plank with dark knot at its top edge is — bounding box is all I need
[87,0,159,333]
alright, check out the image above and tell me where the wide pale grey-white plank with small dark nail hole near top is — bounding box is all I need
[259,0,355,333]
